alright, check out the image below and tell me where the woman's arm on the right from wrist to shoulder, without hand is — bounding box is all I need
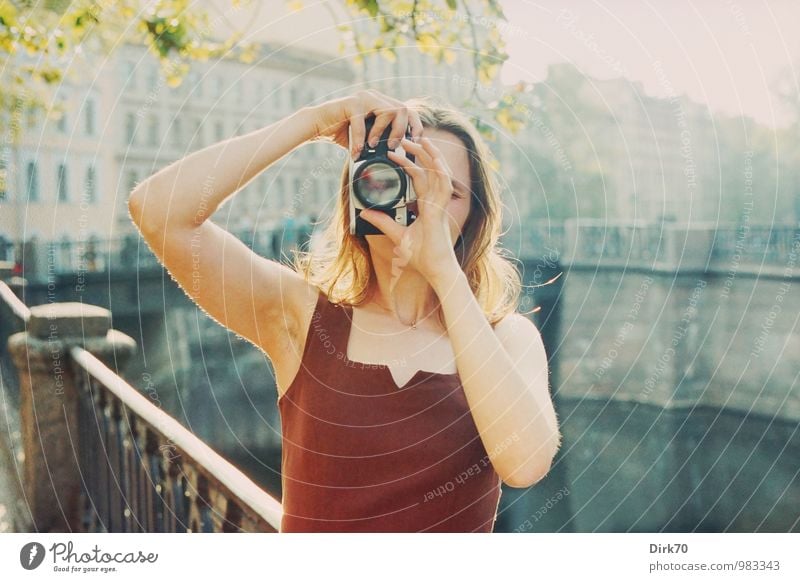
[429,262,561,487]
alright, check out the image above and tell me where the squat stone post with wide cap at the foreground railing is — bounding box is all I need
[8,303,136,532]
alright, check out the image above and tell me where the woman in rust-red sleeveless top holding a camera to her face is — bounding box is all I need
[129,91,560,532]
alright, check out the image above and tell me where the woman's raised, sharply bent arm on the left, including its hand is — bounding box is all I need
[128,92,421,386]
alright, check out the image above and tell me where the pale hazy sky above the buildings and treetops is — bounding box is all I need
[206,0,800,127]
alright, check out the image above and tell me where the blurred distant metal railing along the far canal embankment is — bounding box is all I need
[7,219,800,281]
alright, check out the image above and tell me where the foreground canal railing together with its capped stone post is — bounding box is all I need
[0,281,282,532]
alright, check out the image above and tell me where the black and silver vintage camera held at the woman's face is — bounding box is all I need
[349,115,417,235]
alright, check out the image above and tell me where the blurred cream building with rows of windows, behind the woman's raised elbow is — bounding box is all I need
[0,39,353,249]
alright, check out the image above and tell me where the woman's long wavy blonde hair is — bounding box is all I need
[293,97,522,326]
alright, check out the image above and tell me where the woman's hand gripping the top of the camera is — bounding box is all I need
[312,90,422,158]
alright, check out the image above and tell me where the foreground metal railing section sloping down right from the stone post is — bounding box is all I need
[71,346,282,532]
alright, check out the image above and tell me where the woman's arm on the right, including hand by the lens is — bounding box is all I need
[361,137,561,487]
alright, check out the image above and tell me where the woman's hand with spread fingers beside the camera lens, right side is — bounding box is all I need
[361,137,457,284]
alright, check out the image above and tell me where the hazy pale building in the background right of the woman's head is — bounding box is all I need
[498,63,724,224]
